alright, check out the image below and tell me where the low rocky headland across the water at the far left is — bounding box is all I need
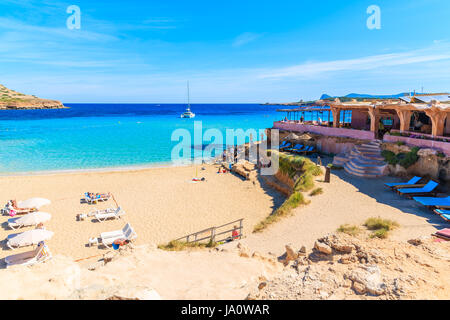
[0,84,67,110]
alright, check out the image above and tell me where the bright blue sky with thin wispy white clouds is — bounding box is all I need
[0,0,450,103]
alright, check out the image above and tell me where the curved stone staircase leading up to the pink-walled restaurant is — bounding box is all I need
[333,140,387,178]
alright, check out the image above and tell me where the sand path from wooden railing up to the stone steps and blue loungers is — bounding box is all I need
[239,170,448,255]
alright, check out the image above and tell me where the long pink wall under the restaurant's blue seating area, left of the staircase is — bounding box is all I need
[273,121,374,140]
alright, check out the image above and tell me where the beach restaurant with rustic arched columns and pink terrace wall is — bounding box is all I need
[273,93,450,155]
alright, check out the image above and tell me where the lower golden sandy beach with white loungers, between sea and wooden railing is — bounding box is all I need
[0,166,284,260]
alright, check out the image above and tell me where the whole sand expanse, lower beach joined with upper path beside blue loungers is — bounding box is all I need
[0,160,444,260]
